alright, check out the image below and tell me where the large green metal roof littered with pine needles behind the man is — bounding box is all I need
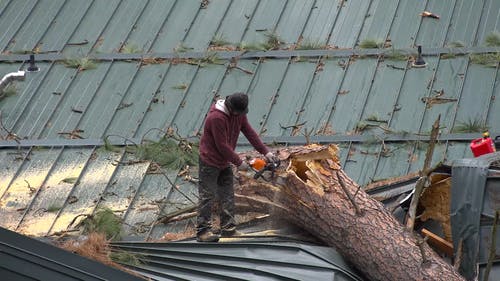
[0,0,500,243]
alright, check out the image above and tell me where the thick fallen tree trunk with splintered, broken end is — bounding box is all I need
[235,145,465,281]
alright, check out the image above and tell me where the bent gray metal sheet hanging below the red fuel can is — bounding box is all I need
[450,152,500,280]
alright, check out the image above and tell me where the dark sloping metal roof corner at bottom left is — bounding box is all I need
[0,227,144,281]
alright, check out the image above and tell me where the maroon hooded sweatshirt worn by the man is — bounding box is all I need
[200,101,269,169]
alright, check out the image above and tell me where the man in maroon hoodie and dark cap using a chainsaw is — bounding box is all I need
[196,93,276,242]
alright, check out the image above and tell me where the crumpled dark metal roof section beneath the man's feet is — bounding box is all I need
[113,239,364,281]
